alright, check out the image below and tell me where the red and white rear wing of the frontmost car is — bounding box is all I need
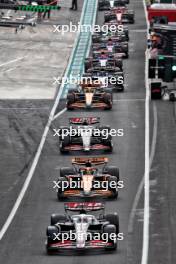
[64,202,105,212]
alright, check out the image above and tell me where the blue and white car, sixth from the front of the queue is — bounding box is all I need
[84,52,123,72]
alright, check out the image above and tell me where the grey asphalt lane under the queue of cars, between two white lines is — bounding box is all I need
[0,2,145,264]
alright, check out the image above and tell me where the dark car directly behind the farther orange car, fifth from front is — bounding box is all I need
[83,66,124,92]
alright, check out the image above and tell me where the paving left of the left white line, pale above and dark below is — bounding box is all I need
[0,1,82,226]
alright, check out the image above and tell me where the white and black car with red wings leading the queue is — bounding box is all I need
[46,202,120,254]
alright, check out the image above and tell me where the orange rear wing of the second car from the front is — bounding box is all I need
[72,157,109,165]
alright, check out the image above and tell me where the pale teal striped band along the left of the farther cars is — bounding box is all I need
[60,0,98,98]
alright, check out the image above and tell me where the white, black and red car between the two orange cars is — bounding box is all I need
[59,117,113,153]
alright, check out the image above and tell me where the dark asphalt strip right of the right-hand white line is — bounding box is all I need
[149,101,176,264]
